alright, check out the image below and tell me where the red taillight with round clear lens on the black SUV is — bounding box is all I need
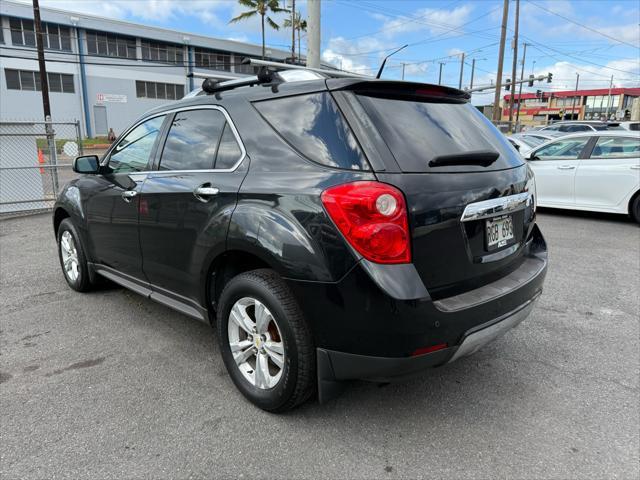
[322,182,411,263]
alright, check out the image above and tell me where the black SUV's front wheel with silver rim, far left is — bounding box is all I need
[58,218,93,292]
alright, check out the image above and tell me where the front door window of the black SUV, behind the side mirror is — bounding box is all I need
[109,115,165,173]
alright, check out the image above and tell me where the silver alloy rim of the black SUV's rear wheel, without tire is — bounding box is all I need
[227,297,285,390]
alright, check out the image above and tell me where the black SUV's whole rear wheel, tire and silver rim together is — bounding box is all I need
[217,269,316,413]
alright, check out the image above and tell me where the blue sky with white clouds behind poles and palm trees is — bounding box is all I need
[20,0,640,104]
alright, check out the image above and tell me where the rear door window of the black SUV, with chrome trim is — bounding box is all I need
[159,109,242,170]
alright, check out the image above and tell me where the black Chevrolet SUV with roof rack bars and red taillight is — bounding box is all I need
[53,73,547,411]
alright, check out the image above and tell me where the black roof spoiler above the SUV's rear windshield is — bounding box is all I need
[327,78,471,102]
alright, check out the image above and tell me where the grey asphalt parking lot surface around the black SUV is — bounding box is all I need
[0,211,640,479]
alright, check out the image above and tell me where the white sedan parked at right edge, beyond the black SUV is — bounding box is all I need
[527,130,640,223]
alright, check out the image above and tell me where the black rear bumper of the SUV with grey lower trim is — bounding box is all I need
[289,227,547,400]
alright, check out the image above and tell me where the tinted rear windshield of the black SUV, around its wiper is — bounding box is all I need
[358,95,523,172]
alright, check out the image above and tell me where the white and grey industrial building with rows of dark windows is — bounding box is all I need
[0,0,290,137]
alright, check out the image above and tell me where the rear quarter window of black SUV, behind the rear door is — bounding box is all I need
[253,93,369,170]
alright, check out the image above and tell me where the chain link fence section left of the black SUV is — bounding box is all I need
[0,121,93,216]
